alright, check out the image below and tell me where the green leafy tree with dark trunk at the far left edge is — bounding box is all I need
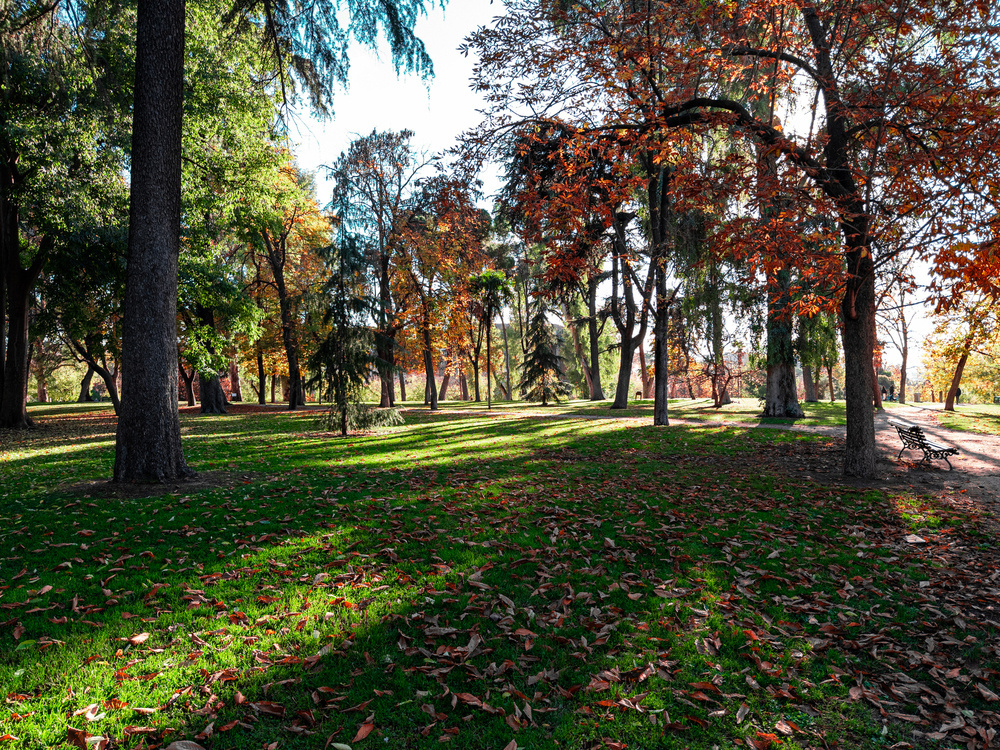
[0,2,127,428]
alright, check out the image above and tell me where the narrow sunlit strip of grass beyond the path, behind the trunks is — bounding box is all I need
[403,398,847,426]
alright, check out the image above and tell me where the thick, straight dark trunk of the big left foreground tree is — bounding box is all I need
[114,0,194,483]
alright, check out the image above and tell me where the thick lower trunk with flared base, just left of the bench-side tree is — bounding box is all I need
[764,268,805,419]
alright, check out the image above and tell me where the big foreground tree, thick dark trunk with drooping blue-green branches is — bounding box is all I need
[114,0,442,482]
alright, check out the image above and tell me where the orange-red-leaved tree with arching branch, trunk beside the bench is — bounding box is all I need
[471,0,1000,476]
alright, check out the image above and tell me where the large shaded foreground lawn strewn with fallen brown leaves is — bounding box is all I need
[0,402,1000,750]
